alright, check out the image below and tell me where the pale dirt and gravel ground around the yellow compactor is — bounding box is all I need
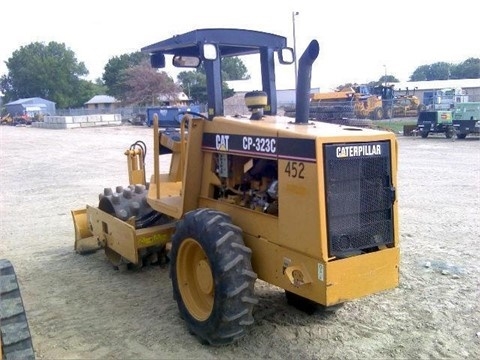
[0,126,480,359]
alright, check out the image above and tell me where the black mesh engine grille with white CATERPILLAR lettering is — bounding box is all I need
[324,141,395,257]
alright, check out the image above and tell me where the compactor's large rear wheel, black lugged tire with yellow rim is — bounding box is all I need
[170,209,258,345]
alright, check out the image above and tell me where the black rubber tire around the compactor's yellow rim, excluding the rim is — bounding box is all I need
[170,208,258,346]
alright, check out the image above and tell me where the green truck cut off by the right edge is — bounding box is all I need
[452,102,480,139]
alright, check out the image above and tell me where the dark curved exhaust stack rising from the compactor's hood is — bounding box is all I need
[295,40,320,124]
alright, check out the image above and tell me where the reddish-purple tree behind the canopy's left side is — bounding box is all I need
[118,61,180,106]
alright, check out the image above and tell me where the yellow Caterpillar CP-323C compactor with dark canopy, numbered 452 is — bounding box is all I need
[72,29,399,345]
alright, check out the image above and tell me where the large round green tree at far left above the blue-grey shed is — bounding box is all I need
[0,41,94,108]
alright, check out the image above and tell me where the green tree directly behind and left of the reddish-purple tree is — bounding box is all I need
[102,51,149,99]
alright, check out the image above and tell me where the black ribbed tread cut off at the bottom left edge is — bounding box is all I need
[0,259,35,360]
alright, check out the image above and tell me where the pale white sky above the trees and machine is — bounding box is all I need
[0,0,480,91]
